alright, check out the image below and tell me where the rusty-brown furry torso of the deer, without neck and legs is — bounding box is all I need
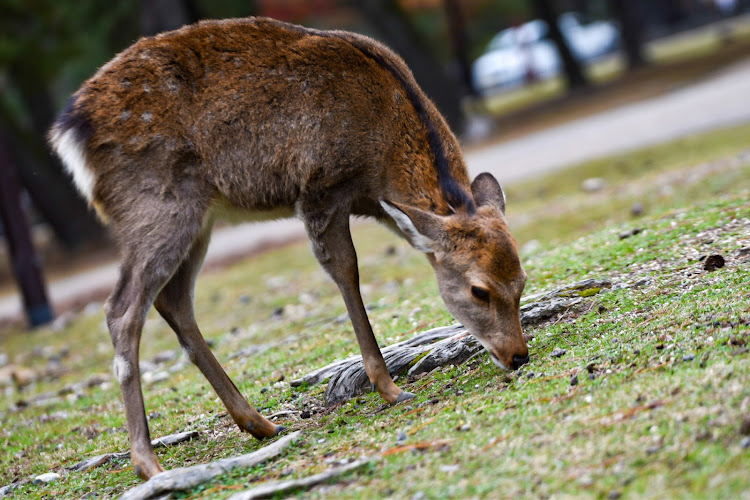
[61,19,419,217]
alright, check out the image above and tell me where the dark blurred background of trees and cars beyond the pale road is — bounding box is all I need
[0,0,750,324]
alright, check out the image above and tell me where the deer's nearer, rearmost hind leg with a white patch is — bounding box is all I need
[105,199,212,479]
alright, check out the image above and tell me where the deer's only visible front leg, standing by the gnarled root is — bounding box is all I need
[303,203,414,404]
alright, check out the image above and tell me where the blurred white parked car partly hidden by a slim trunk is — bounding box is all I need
[472,12,620,94]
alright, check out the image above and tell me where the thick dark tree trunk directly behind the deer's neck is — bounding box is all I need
[351,0,464,134]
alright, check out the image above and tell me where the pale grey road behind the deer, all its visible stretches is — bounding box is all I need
[0,59,750,325]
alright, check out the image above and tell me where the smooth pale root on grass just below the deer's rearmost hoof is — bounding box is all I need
[120,431,300,500]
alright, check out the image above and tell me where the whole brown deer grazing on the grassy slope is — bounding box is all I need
[50,18,528,478]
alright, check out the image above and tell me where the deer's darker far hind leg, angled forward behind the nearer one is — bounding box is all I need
[154,222,284,439]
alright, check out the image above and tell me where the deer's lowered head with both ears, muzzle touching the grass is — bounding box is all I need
[383,173,529,370]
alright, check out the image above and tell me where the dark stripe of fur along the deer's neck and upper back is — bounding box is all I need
[290,21,476,215]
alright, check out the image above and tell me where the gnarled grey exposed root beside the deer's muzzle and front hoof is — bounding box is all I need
[291,279,612,404]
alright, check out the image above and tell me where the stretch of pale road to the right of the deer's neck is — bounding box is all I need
[466,59,750,183]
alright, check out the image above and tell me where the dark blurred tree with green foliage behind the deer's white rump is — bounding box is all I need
[0,0,138,248]
